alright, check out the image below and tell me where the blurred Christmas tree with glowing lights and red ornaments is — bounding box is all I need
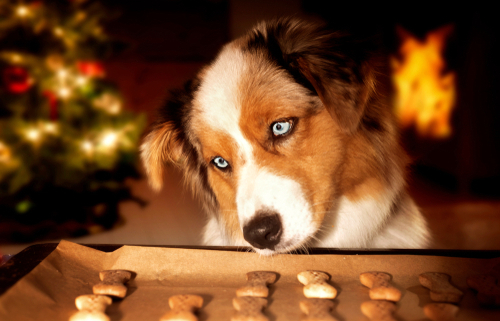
[0,0,145,241]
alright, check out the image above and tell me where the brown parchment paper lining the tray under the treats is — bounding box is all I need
[0,241,500,321]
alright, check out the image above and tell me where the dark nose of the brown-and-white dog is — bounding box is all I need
[243,211,283,250]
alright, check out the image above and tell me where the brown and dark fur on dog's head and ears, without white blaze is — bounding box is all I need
[142,19,426,250]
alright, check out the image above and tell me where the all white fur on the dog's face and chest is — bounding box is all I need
[194,46,429,255]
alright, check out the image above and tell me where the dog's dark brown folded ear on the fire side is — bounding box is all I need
[254,18,375,133]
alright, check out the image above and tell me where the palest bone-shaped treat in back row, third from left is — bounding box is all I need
[297,271,337,299]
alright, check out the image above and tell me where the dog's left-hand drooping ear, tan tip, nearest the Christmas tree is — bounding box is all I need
[141,81,197,191]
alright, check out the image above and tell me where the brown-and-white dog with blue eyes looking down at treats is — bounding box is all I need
[141,18,430,255]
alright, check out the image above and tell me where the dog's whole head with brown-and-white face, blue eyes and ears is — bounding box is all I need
[142,19,390,254]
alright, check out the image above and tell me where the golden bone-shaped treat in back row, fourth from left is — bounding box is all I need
[359,272,401,302]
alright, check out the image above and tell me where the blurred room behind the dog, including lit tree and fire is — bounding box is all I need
[0,0,500,260]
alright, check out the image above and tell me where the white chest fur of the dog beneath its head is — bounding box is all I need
[203,188,430,250]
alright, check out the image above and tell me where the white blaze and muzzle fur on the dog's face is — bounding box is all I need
[195,46,318,254]
